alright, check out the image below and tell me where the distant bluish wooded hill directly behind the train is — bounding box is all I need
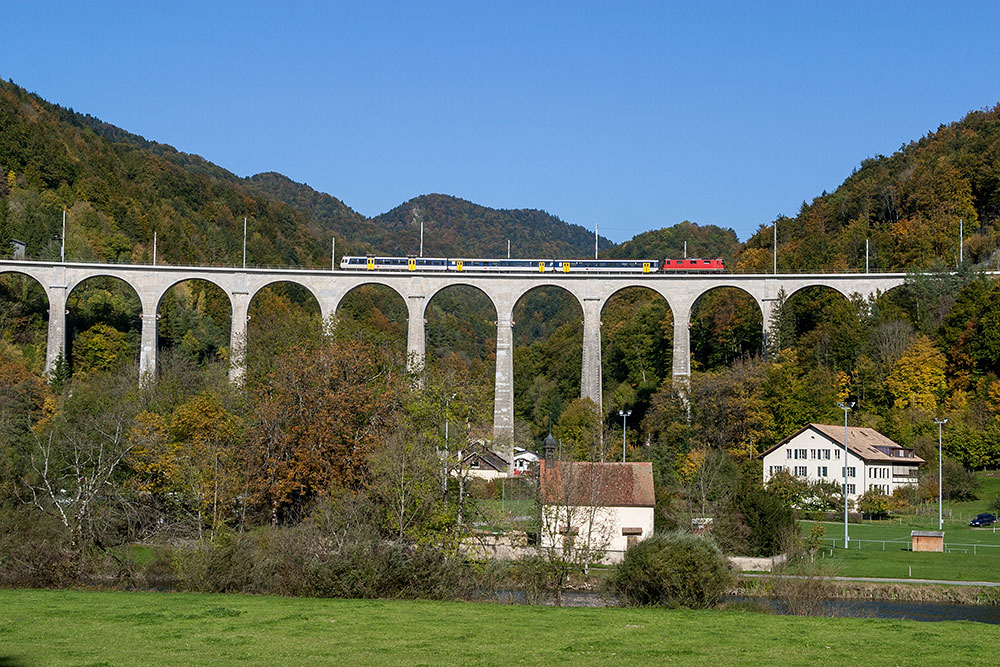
[372,194,612,258]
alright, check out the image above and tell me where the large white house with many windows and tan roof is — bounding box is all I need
[760,424,924,499]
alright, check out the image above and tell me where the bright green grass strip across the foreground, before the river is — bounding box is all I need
[0,590,1000,665]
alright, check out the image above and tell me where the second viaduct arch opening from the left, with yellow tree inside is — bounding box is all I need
[65,272,143,373]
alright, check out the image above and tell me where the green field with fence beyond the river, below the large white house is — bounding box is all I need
[799,473,1000,581]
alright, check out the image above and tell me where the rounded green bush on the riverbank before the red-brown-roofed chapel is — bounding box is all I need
[608,531,733,609]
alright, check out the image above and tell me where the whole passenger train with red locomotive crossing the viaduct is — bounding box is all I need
[340,255,725,273]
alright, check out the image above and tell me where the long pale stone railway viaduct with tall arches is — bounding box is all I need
[0,260,906,439]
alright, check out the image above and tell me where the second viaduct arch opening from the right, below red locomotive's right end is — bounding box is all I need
[689,284,766,369]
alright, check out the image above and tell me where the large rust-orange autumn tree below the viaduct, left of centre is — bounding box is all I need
[248,338,406,522]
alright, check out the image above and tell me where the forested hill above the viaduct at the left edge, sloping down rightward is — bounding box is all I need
[0,81,340,265]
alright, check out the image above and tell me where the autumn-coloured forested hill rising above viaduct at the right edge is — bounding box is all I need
[737,105,1000,272]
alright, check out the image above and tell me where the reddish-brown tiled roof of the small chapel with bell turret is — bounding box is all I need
[539,460,656,507]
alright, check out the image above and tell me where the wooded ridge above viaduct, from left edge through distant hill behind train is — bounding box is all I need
[0,80,612,267]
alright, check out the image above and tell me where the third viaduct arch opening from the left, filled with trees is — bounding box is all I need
[154,276,233,368]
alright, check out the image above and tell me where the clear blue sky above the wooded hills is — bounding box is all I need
[0,0,1000,241]
